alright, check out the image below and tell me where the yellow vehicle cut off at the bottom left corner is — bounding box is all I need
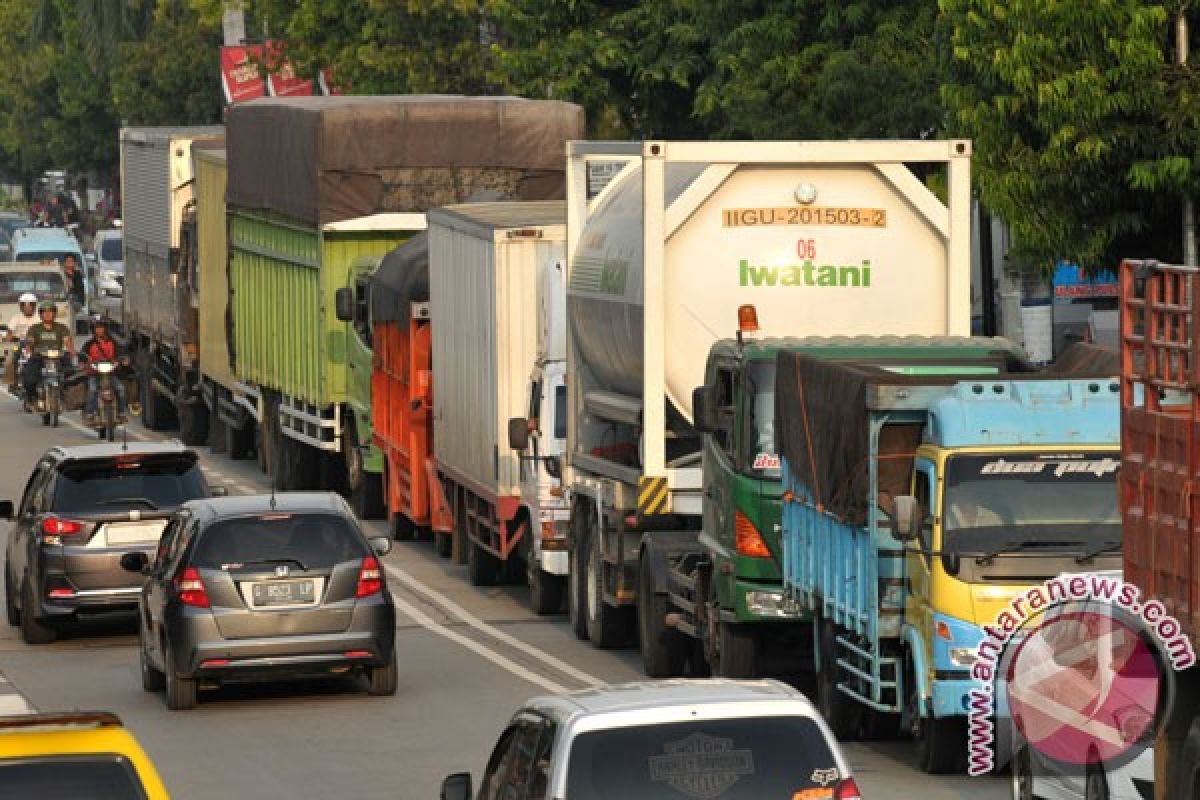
[0,711,170,800]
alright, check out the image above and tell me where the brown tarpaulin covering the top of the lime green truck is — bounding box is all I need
[227,95,583,224]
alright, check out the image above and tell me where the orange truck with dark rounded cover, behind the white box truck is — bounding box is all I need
[371,233,454,555]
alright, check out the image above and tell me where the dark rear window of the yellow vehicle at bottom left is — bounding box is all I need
[0,756,146,800]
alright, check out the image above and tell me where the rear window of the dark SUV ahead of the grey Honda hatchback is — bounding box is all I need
[54,458,208,513]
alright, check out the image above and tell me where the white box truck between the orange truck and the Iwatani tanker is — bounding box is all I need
[427,201,566,592]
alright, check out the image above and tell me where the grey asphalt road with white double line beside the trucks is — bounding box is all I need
[0,395,1009,800]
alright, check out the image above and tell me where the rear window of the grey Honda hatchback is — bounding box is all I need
[192,513,370,570]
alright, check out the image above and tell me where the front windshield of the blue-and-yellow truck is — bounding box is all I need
[942,451,1121,553]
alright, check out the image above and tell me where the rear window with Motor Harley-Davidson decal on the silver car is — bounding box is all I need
[566,716,846,800]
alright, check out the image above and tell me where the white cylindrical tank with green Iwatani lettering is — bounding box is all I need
[568,162,968,429]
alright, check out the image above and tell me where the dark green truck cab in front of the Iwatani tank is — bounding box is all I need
[638,337,1020,678]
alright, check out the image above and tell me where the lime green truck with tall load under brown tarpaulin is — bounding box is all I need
[220,96,583,517]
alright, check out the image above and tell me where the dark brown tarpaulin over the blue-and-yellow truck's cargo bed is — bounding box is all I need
[775,345,1128,525]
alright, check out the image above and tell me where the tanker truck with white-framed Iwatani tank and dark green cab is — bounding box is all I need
[565,140,971,662]
